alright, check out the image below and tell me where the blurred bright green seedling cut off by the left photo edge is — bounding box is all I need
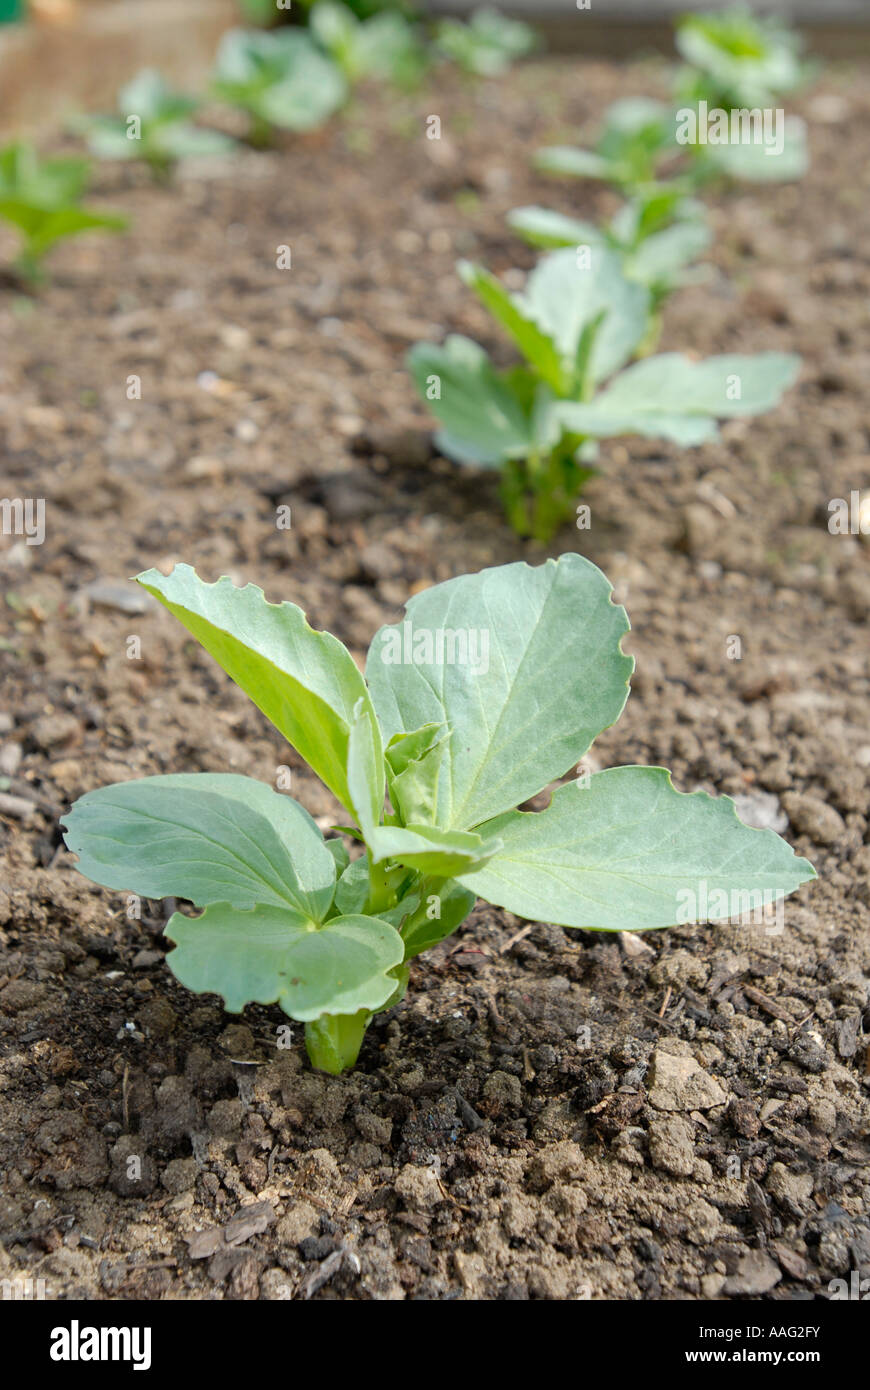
[0,143,126,285]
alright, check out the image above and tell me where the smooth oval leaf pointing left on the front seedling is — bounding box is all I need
[63,773,335,923]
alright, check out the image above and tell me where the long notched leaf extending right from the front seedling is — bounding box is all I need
[460,767,816,931]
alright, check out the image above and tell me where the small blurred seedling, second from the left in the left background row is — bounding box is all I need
[76,68,235,179]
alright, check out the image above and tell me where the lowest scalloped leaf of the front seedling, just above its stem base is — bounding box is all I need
[165,902,404,1023]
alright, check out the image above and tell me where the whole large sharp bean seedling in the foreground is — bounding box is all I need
[64,555,814,1073]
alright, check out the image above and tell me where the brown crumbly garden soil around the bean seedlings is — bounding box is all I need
[0,63,870,1300]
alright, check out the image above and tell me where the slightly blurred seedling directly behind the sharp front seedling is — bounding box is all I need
[409,246,801,542]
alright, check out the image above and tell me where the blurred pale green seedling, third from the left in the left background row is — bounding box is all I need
[211,29,347,145]
